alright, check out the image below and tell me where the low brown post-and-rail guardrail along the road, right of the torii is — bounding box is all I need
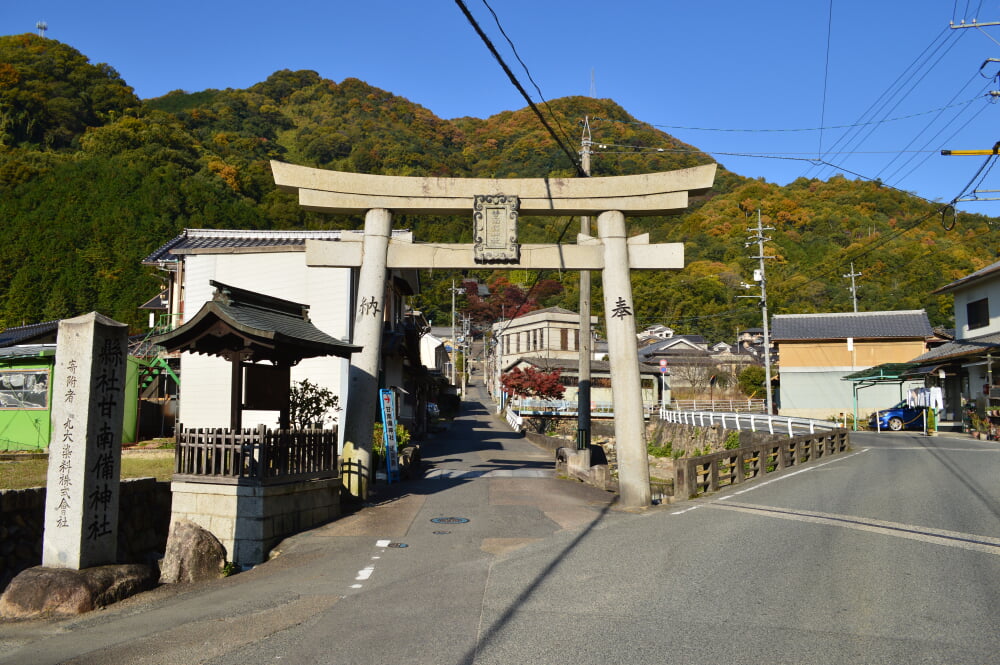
[674,429,850,499]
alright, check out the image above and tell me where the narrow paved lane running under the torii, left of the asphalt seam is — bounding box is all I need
[0,386,614,665]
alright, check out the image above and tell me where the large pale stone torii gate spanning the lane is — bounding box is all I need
[271,161,716,508]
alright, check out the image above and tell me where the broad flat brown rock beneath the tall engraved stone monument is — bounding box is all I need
[0,564,156,619]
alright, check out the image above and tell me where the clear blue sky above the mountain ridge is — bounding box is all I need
[0,0,1000,216]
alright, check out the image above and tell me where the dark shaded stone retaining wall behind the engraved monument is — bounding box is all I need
[0,478,170,591]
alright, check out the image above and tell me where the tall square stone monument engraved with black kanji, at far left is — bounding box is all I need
[42,312,128,570]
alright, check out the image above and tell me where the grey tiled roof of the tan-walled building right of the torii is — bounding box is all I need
[771,309,933,342]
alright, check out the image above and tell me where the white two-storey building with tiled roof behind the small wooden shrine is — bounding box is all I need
[143,229,421,443]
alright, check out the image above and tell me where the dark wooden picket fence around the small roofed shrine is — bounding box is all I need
[174,426,339,485]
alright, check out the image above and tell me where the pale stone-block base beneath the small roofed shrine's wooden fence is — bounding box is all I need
[170,478,341,566]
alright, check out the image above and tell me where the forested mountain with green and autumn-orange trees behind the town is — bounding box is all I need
[0,34,996,340]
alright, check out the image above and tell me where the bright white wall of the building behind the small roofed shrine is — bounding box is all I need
[178,252,353,444]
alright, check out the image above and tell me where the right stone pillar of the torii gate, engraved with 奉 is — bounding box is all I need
[597,210,652,507]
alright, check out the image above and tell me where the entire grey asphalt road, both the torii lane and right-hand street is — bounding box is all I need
[0,386,1000,665]
